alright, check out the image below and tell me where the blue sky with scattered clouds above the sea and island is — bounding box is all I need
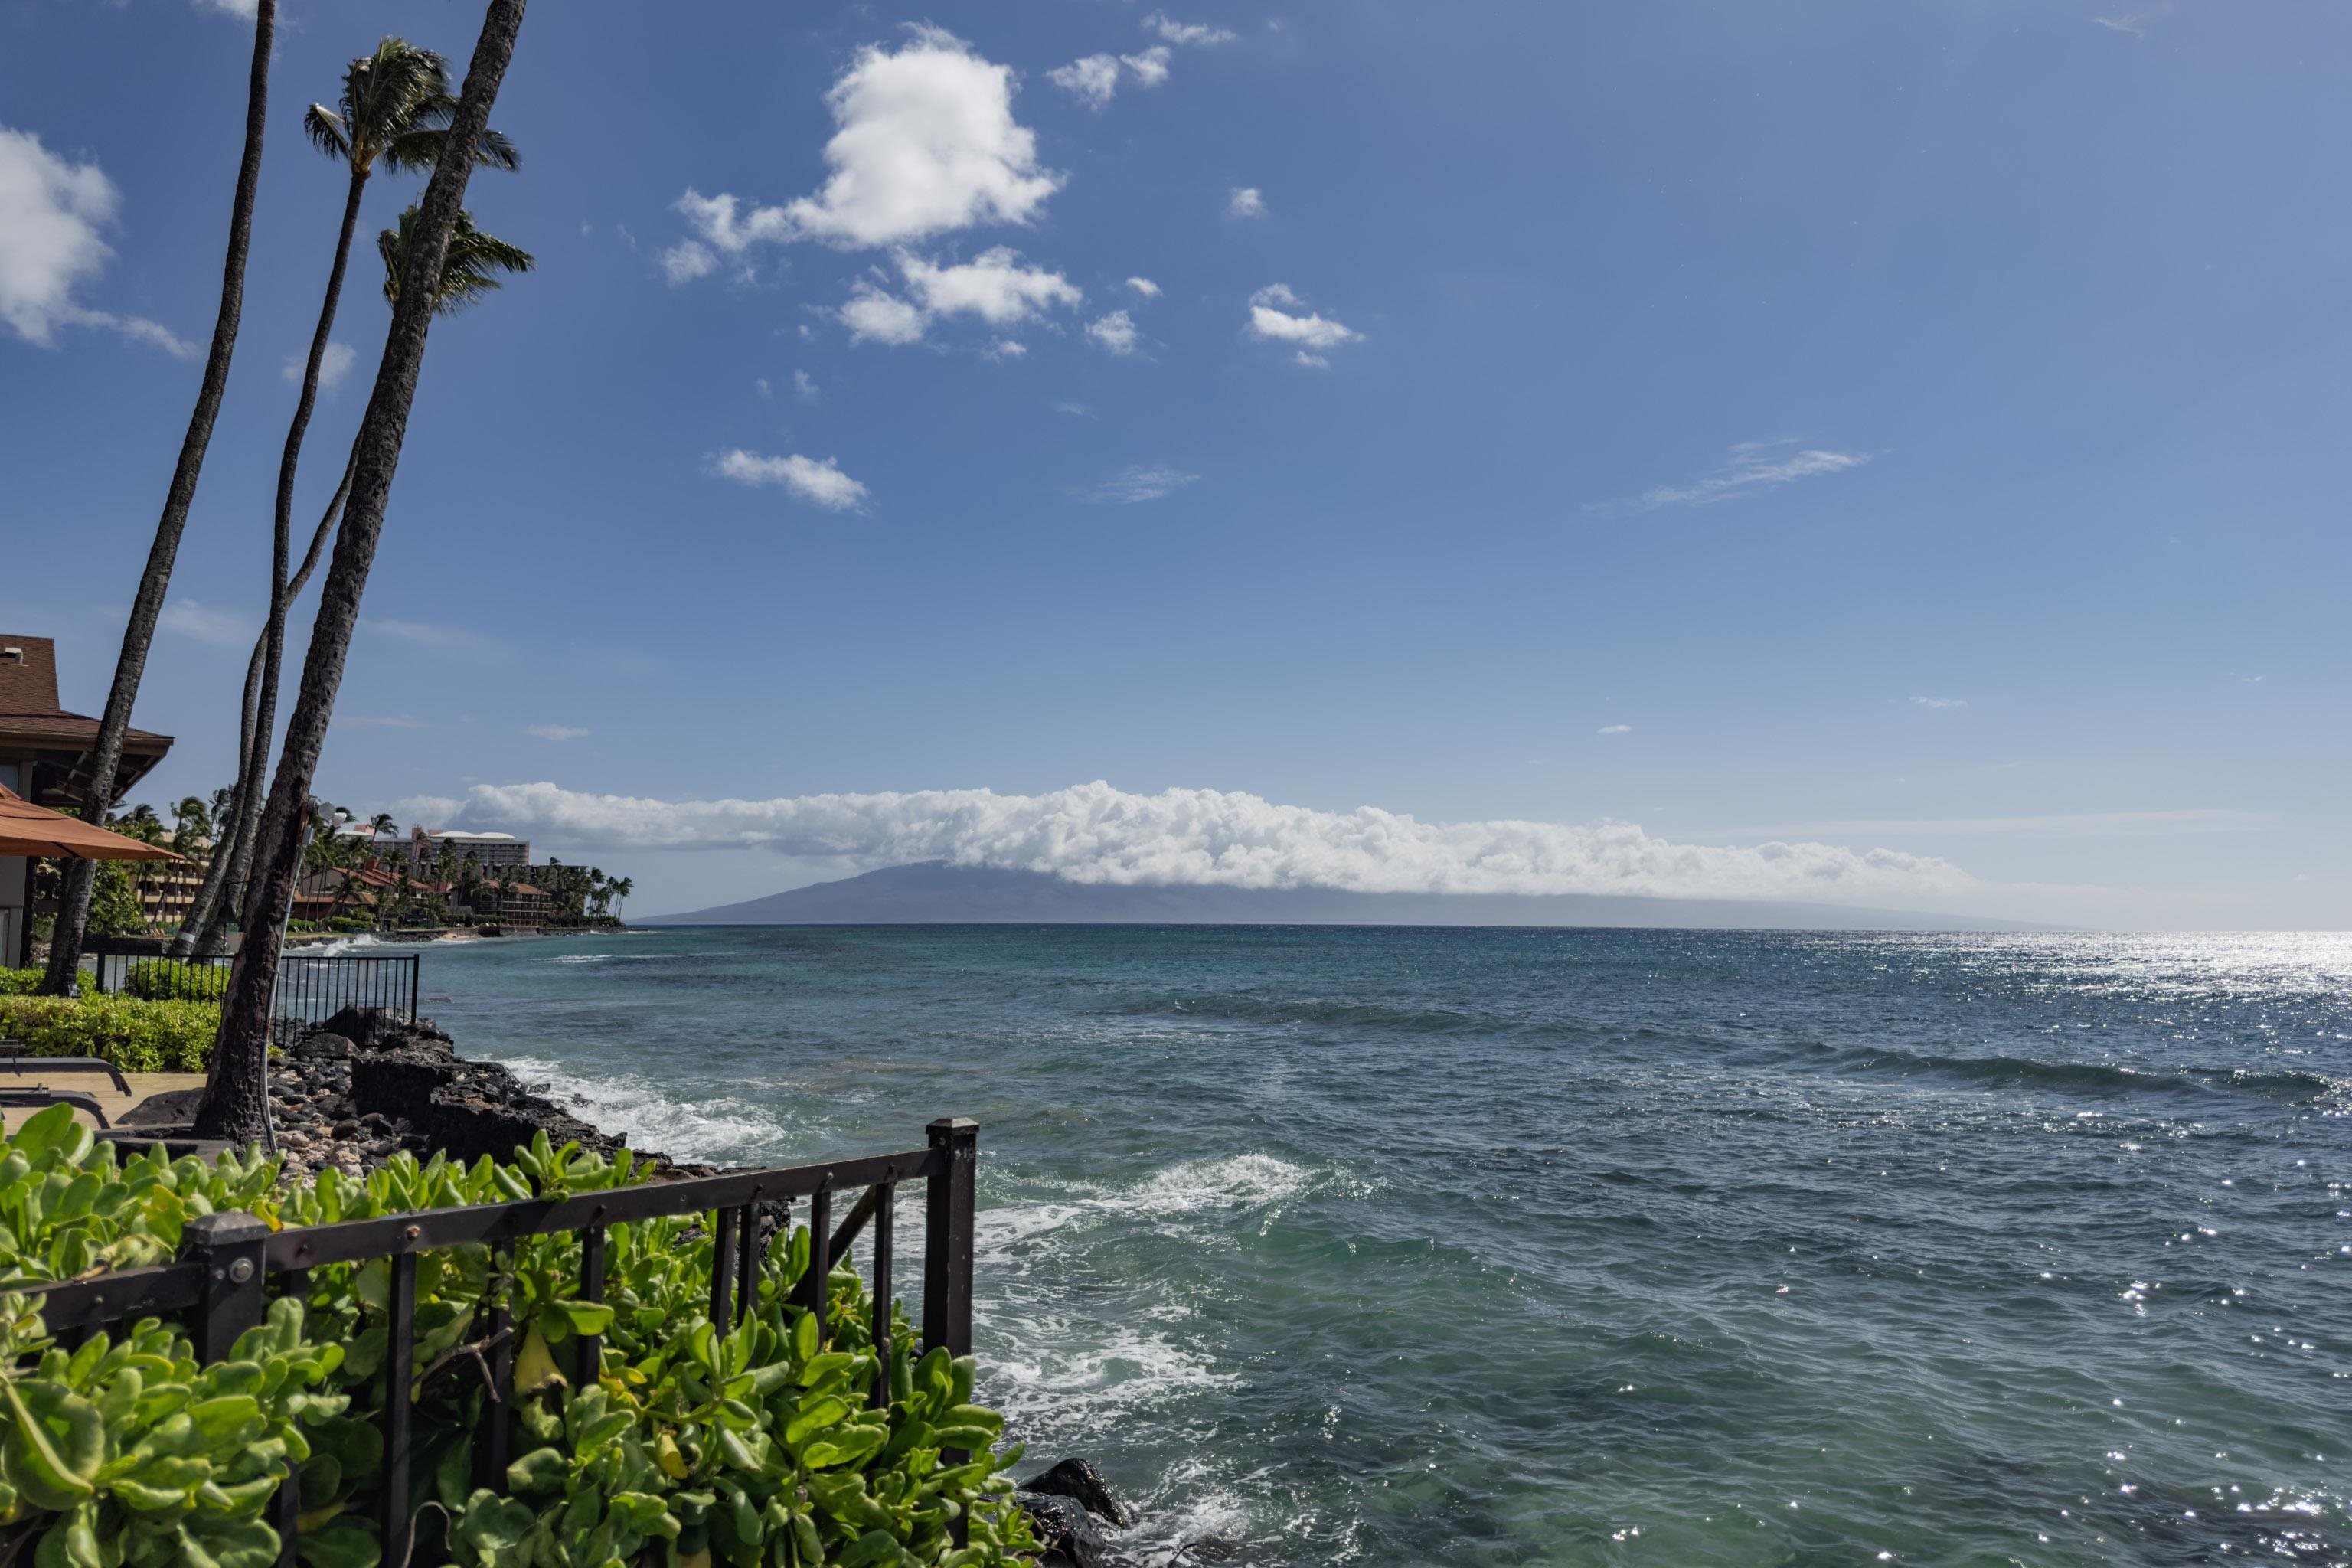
[0,0,2352,926]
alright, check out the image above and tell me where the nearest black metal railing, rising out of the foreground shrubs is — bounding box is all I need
[11,1116,981,1568]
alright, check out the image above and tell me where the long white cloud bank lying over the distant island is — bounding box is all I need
[400,780,1985,903]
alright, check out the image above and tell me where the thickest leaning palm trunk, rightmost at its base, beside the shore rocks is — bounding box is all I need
[195,0,524,1142]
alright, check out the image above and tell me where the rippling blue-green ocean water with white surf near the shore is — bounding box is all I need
[371,929,2352,1566]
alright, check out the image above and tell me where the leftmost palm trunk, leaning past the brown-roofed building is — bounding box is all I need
[40,0,277,997]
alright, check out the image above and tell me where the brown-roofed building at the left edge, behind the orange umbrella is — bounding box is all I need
[0,632,172,969]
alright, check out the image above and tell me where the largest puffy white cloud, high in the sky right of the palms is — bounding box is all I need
[663,26,1060,263]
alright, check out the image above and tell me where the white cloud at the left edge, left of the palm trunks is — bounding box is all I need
[0,125,195,360]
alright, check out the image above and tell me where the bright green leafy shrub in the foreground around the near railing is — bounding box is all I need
[0,1109,1035,1568]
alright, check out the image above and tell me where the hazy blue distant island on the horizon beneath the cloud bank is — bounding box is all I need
[632,861,2051,931]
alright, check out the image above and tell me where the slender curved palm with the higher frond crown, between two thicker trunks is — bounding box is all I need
[176,38,518,952]
